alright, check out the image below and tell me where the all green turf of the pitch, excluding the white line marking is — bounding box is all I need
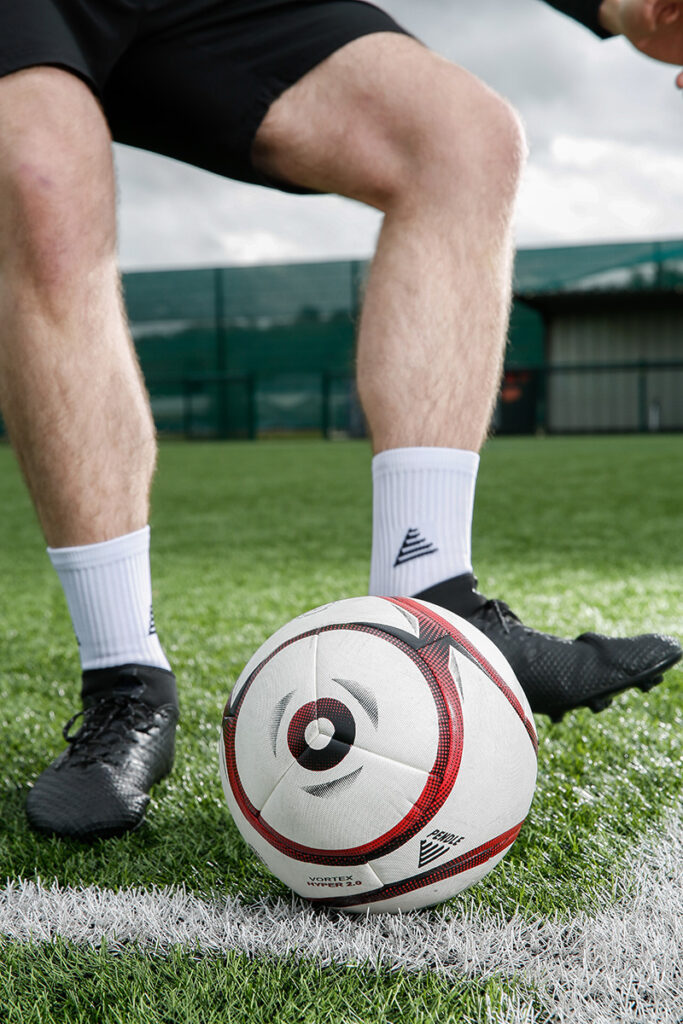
[0,436,683,1022]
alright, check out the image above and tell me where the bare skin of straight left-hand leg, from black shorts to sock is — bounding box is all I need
[0,68,156,547]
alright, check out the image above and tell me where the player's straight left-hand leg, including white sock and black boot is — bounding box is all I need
[0,68,176,837]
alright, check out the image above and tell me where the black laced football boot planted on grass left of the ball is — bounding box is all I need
[27,665,178,842]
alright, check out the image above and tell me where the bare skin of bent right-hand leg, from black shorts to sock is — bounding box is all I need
[254,34,524,452]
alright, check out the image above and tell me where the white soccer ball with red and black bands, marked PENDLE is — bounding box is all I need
[220,597,538,912]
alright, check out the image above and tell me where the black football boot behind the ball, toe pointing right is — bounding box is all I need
[415,572,683,722]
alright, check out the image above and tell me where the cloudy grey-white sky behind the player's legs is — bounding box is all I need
[116,0,683,269]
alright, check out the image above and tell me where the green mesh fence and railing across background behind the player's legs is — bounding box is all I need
[0,256,683,438]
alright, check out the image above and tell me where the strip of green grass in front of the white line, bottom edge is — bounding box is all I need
[0,942,542,1024]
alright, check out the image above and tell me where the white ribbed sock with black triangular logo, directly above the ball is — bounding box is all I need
[370,447,479,597]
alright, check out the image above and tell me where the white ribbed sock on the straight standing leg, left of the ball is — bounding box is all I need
[47,526,170,672]
